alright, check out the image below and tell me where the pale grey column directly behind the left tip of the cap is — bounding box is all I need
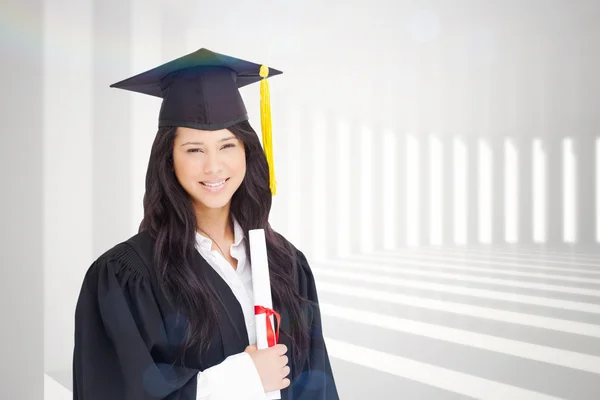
[92,0,132,255]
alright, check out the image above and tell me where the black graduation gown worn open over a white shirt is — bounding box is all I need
[73,232,339,400]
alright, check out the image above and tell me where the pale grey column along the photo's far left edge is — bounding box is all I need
[0,0,44,399]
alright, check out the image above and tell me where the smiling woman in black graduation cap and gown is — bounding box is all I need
[73,49,338,400]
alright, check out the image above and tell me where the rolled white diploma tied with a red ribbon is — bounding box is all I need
[249,229,281,400]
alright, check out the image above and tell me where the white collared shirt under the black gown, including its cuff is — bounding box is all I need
[196,216,267,400]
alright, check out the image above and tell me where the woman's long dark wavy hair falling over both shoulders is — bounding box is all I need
[139,121,310,373]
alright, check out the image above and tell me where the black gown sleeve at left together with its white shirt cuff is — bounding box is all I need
[73,244,265,400]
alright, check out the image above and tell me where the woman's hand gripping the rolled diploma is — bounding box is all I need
[244,344,290,392]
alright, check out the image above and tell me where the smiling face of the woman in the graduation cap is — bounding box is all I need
[173,127,246,210]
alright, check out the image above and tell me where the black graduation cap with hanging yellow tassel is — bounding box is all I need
[110,48,282,195]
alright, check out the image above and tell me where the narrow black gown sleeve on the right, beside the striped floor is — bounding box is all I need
[294,250,339,400]
